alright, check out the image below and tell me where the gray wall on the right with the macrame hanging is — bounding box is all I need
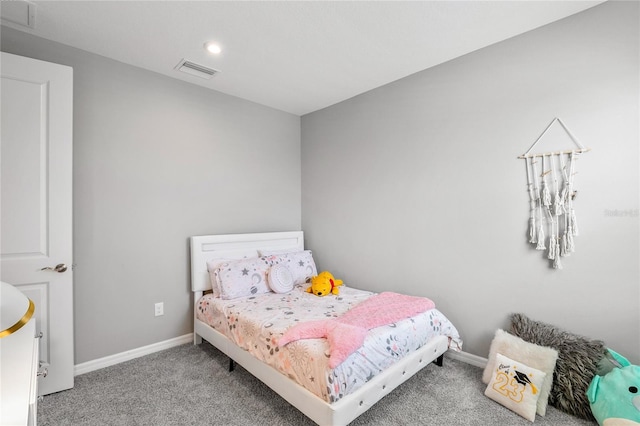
[302,2,640,363]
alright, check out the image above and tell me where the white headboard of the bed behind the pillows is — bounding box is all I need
[191,231,304,292]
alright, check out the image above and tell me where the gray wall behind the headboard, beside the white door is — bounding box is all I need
[2,27,301,364]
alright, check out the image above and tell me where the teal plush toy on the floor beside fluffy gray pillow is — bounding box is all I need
[587,349,640,426]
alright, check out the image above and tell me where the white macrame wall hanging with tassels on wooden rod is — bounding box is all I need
[518,117,590,269]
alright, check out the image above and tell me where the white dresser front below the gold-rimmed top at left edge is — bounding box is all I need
[0,318,40,426]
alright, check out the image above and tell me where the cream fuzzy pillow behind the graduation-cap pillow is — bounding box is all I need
[482,330,558,416]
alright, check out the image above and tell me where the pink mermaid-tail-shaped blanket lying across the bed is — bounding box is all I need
[278,292,436,368]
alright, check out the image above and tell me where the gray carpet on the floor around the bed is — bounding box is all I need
[38,343,595,426]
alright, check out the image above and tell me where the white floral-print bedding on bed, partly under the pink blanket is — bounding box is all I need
[196,284,462,403]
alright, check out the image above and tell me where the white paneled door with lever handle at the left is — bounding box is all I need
[0,53,74,395]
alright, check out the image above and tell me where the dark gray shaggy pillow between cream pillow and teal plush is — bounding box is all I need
[509,314,606,420]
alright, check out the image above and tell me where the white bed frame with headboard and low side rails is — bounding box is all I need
[191,231,449,426]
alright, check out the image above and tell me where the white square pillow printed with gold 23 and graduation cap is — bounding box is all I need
[484,354,547,422]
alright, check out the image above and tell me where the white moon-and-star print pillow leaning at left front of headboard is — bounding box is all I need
[215,257,271,299]
